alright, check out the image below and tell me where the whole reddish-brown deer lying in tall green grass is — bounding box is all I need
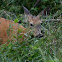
[0,7,43,44]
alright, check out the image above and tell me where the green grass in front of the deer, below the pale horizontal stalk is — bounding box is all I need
[0,14,62,62]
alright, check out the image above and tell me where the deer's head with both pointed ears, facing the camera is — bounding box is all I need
[23,6,43,38]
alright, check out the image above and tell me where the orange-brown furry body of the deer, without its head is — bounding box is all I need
[0,18,26,44]
